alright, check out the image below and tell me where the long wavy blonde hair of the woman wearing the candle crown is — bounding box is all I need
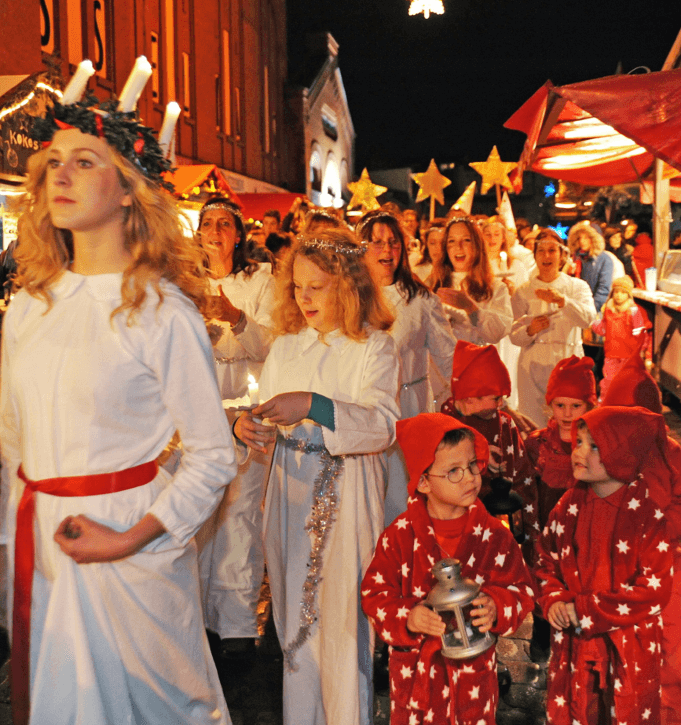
[14,146,208,325]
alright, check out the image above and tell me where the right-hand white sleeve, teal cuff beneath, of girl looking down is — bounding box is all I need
[322,334,400,456]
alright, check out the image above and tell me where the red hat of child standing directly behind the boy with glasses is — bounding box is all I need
[452,340,511,400]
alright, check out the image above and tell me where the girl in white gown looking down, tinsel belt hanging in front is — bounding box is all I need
[235,230,399,725]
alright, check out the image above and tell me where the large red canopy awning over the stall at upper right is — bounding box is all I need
[504,69,681,198]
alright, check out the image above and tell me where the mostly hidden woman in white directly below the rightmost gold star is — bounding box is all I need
[481,216,529,410]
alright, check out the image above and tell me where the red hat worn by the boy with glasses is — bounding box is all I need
[397,413,489,496]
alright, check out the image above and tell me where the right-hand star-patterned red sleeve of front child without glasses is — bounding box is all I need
[575,519,673,634]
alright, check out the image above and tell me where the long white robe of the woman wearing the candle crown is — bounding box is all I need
[0,272,236,725]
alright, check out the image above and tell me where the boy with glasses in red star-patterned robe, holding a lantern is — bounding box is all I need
[361,413,534,725]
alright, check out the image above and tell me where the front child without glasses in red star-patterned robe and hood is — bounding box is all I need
[535,406,672,725]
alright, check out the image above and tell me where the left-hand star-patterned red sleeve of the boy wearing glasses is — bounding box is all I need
[361,515,428,647]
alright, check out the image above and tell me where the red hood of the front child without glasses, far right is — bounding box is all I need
[572,405,669,483]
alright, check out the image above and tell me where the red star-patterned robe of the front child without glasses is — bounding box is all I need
[535,478,672,725]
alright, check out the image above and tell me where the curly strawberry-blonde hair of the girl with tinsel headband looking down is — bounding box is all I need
[272,229,395,342]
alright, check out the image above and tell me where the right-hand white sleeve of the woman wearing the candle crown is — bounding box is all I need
[148,302,236,545]
